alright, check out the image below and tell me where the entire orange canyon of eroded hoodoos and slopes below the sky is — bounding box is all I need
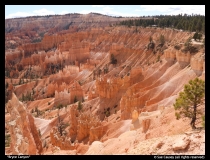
[5,14,205,155]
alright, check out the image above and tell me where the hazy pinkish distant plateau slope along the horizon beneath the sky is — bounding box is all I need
[5,13,140,32]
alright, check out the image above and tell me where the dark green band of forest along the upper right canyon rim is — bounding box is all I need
[117,14,205,34]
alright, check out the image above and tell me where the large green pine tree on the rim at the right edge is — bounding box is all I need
[174,78,205,129]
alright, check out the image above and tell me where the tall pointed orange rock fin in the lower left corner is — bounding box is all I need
[7,93,42,155]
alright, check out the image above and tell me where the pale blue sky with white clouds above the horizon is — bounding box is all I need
[5,5,205,19]
